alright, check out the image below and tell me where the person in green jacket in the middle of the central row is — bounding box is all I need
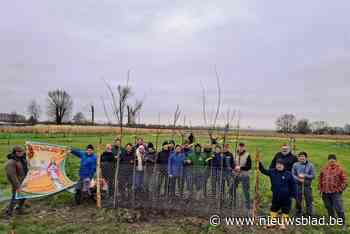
[186,144,207,200]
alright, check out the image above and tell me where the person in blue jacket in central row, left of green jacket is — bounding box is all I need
[168,145,186,197]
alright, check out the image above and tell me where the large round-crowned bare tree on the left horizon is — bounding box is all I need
[47,89,73,124]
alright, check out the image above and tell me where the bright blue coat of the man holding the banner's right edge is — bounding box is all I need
[71,149,96,180]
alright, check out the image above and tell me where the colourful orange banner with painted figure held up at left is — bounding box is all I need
[16,142,75,199]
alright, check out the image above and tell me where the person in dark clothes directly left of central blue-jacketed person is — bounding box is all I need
[157,141,170,196]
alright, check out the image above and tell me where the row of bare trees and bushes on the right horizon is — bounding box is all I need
[275,114,350,135]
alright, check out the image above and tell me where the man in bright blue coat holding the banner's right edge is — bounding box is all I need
[70,145,96,205]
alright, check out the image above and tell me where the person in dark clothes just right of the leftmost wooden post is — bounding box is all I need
[101,144,116,196]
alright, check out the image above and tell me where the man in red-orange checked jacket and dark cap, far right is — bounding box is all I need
[318,154,347,227]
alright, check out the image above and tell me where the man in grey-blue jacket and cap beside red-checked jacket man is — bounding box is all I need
[292,152,315,216]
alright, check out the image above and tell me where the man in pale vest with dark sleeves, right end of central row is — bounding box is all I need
[233,142,252,210]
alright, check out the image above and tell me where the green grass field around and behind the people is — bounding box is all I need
[0,133,350,233]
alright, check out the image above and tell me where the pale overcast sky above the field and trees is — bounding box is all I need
[0,0,350,128]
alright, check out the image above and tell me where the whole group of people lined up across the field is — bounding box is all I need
[5,134,347,229]
